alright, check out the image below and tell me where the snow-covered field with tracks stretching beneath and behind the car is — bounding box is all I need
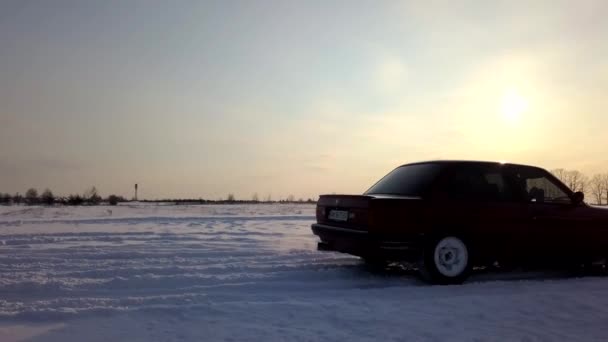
[0,205,608,342]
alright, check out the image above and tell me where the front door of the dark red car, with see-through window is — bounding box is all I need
[518,167,595,263]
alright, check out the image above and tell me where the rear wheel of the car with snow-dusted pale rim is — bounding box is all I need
[418,234,472,285]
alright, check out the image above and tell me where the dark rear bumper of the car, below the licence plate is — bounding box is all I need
[312,223,422,261]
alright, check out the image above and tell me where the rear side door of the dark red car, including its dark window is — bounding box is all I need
[434,164,527,263]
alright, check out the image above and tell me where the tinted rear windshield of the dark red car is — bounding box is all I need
[365,163,441,196]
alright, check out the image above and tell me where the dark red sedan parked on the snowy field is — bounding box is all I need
[312,161,608,284]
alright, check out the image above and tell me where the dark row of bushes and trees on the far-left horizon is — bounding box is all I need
[0,186,127,205]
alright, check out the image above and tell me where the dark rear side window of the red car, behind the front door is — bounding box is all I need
[445,166,514,202]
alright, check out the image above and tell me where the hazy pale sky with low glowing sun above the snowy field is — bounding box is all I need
[0,0,608,199]
